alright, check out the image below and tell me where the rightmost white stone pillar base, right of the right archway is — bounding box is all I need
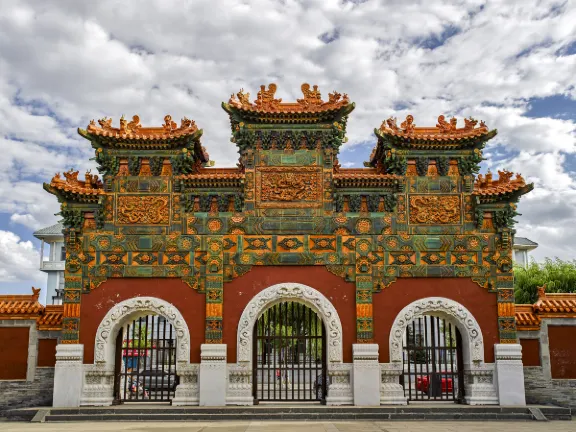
[494,344,526,406]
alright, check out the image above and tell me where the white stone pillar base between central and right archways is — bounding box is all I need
[352,344,380,406]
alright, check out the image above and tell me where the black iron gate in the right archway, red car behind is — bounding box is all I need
[402,315,464,402]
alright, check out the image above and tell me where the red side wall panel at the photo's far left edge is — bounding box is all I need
[0,327,30,380]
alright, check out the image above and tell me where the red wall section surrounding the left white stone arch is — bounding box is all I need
[80,278,206,363]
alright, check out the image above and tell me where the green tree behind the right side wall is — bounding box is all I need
[514,258,576,304]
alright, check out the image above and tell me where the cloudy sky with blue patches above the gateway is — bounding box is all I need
[0,0,576,293]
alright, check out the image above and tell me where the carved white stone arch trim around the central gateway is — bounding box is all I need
[236,282,342,364]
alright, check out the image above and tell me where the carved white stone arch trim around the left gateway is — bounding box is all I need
[94,297,190,367]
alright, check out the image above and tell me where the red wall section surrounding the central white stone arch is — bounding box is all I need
[224,266,356,363]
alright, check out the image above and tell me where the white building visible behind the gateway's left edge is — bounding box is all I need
[34,223,66,305]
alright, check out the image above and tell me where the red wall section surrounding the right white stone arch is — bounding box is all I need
[373,278,499,363]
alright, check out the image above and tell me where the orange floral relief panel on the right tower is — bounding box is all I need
[410,195,461,225]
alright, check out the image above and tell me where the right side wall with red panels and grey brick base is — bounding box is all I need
[518,318,576,409]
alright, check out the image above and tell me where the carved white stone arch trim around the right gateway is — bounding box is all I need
[390,297,484,366]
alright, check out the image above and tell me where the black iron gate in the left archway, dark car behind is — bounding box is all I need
[114,315,178,402]
